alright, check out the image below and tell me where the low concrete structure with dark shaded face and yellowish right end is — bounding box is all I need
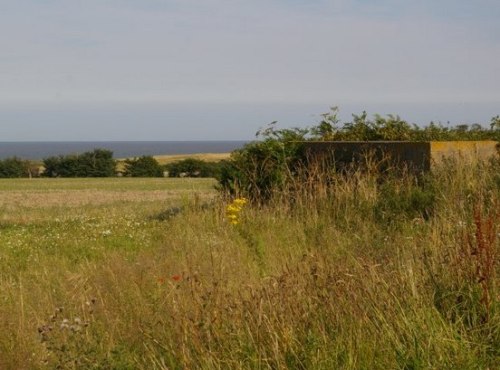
[303,141,497,172]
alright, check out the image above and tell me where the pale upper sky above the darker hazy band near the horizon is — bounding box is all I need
[0,0,500,139]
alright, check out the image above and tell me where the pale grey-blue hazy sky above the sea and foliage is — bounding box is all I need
[0,0,500,141]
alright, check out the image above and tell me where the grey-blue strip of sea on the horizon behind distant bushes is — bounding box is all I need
[0,141,247,160]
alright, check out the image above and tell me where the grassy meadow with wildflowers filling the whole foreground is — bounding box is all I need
[0,161,500,369]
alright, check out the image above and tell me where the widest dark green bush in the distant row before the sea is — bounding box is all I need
[43,149,116,177]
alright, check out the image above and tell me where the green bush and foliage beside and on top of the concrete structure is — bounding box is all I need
[218,107,500,201]
